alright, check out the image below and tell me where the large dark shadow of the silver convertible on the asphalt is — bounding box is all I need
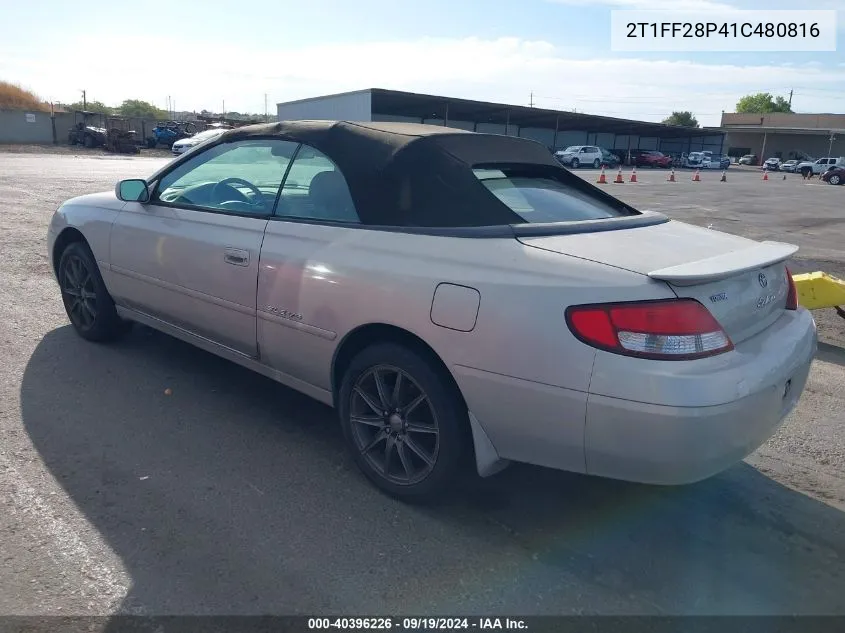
[21,326,845,615]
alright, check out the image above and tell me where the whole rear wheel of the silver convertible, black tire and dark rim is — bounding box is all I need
[338,343,469,501]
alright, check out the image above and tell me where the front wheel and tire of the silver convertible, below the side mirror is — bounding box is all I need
[58,242,129,342]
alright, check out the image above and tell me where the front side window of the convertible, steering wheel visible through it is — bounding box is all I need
[153,139,297,216]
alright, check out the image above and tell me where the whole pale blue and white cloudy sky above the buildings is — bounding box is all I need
[0,0,845,126]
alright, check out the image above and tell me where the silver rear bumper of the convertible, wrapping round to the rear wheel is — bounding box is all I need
[453,309,817,485]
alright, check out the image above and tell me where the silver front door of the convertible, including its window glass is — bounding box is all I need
[111,139,297,357]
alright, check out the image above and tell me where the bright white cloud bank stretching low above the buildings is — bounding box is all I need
[0,37,845,125]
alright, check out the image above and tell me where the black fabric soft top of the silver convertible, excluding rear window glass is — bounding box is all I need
[150,121,644,231]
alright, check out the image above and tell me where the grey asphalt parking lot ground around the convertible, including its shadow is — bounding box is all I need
[0,153,845,615]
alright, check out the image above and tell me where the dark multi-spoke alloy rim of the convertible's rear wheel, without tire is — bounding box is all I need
[349,365,440,486]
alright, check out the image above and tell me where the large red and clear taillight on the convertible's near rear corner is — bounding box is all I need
[566,299,733,360]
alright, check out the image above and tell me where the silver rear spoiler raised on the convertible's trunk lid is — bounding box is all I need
[648,242,798,286]
